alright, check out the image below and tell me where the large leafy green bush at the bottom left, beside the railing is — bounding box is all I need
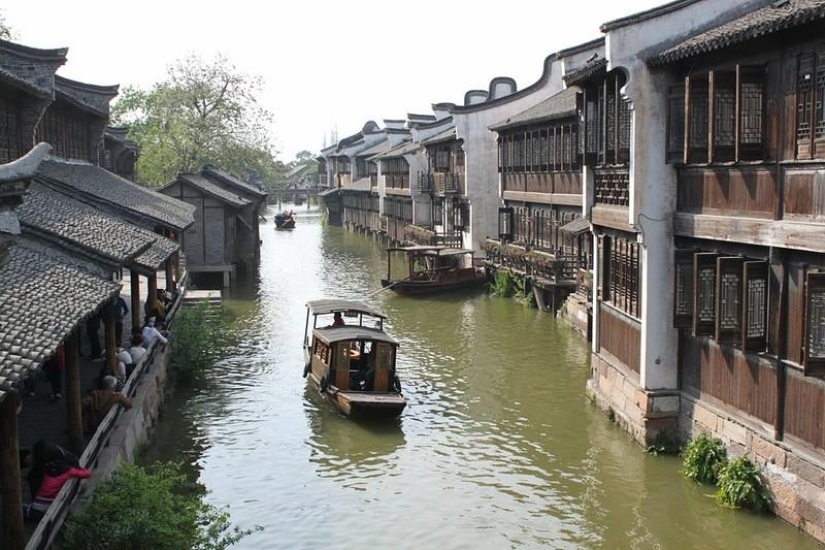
[63,463,261,550]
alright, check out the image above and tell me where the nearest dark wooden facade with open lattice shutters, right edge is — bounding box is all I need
[667,23,825,449]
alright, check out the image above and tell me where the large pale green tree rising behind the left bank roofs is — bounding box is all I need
[112,54,277,185]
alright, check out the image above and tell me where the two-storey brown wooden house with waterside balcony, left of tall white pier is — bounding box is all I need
[485,86,591,316]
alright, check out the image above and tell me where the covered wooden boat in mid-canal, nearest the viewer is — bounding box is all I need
[304,300,407,418]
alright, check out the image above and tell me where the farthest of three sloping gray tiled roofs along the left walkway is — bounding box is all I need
[38,159,195,231]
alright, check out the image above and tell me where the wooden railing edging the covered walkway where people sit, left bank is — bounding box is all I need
[26,274,187,550]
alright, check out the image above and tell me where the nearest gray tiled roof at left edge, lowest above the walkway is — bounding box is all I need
[0,243,120,400]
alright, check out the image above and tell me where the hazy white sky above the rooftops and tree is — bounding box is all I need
[6,0,664,161]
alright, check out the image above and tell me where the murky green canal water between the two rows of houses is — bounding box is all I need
[145,209,820,550]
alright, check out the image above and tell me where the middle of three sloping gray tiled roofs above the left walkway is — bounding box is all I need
[17,182,159,263]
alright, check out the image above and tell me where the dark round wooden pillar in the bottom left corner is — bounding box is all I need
[0,391,26,550]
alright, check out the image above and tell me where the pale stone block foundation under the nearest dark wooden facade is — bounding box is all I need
[679,396,825,541]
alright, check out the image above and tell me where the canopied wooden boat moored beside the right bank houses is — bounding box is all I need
[381,246,487,294]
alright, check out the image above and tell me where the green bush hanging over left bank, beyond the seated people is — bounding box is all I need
[172,302,237,378]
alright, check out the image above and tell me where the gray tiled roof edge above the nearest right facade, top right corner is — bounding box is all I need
[650,0,825,65]
